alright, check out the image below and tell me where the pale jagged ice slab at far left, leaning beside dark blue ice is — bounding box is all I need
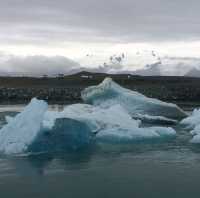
[0,98,48,154]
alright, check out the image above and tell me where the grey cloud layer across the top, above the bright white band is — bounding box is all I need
[0,0,200,44]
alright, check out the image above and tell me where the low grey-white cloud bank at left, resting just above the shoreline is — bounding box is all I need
[0,55,80,76]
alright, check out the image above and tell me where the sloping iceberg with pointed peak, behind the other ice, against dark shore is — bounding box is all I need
[81,78,187,119]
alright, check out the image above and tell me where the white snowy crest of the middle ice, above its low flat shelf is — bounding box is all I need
[43,104,141,133]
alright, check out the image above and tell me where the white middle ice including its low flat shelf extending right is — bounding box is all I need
[43,104,176,142]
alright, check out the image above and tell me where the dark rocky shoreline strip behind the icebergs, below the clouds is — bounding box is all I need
[0,72,200,105]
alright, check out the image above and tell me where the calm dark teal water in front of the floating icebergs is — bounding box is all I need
[0,106,200,198]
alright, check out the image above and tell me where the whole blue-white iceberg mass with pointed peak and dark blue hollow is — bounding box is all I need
[0,78,186,154]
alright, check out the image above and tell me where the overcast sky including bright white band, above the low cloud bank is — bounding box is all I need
[0,0,200,74]
